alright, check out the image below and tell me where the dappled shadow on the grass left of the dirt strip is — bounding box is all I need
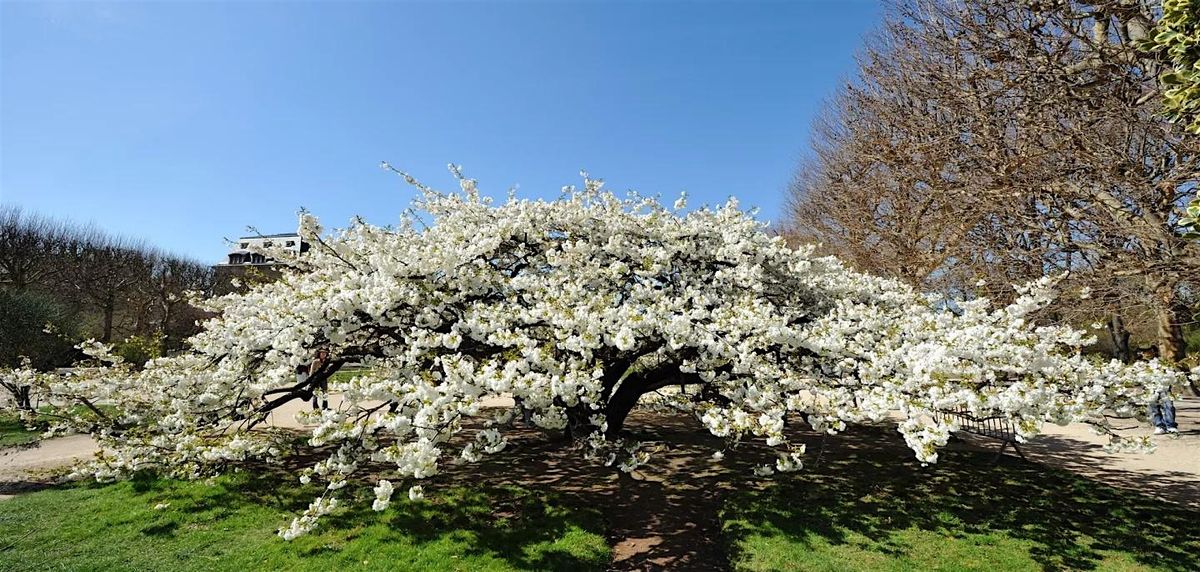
[115,466,608,571]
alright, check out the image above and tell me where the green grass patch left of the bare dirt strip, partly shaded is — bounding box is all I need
[0,475,610,571]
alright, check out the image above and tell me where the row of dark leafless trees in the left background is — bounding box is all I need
[0,205,212,405]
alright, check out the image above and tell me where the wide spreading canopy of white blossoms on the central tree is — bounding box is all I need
[7,168,1184,537]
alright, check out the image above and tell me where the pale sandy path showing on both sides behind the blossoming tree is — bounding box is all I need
[0,396,1200,508]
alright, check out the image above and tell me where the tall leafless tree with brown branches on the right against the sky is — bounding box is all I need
[790,0,1200,361]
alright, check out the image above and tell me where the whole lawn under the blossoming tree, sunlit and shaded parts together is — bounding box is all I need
[0,419,1200,572]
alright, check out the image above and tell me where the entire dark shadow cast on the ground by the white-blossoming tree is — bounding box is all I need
[11,411,1200,571]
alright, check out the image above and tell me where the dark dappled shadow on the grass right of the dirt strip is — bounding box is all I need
[722,429,1200,571]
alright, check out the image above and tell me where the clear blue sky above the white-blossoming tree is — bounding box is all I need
[0,0,881,261]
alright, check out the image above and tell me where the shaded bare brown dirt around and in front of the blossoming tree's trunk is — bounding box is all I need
[403,411,782,571]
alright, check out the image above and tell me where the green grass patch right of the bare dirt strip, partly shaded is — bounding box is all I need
[722,452,1200,572]
